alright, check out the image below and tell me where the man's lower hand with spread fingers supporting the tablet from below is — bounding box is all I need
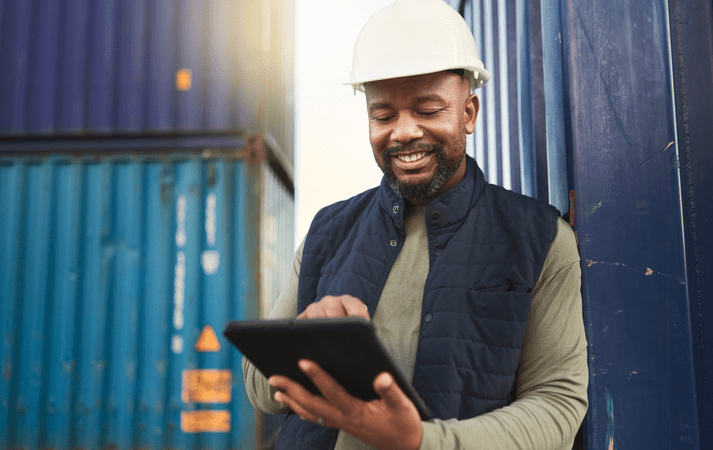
[268,359,423,450]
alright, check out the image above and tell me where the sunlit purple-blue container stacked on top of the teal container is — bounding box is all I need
[0,0,295,163]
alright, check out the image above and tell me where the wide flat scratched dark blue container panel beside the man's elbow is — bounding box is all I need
[560,0,699,449]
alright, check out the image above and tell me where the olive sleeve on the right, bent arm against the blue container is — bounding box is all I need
[421,219,588,450]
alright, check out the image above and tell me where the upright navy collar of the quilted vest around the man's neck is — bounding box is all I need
[379,155,485,229]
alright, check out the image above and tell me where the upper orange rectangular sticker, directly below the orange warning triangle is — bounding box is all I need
[181,369,232,403]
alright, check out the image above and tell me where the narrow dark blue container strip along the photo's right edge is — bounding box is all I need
[669,1,713,442]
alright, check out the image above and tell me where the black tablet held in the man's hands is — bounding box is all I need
[223,317,431,420]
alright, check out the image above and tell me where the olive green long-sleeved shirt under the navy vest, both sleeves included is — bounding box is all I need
[243,207,588,450]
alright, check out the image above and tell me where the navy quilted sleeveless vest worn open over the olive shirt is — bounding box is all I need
[275,157,559,449]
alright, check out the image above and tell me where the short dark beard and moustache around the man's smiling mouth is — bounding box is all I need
[377,144,465,200]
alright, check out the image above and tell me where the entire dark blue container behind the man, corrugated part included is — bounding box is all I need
[462,0,713,449]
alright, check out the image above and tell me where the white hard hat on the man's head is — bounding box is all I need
[345,0,490,92]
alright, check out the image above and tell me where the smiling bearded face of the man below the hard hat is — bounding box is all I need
[365,72,479,204]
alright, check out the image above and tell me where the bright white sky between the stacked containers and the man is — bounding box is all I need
[295,0,393,246]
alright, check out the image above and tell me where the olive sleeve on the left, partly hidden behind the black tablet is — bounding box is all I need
[242,241,304,414]
